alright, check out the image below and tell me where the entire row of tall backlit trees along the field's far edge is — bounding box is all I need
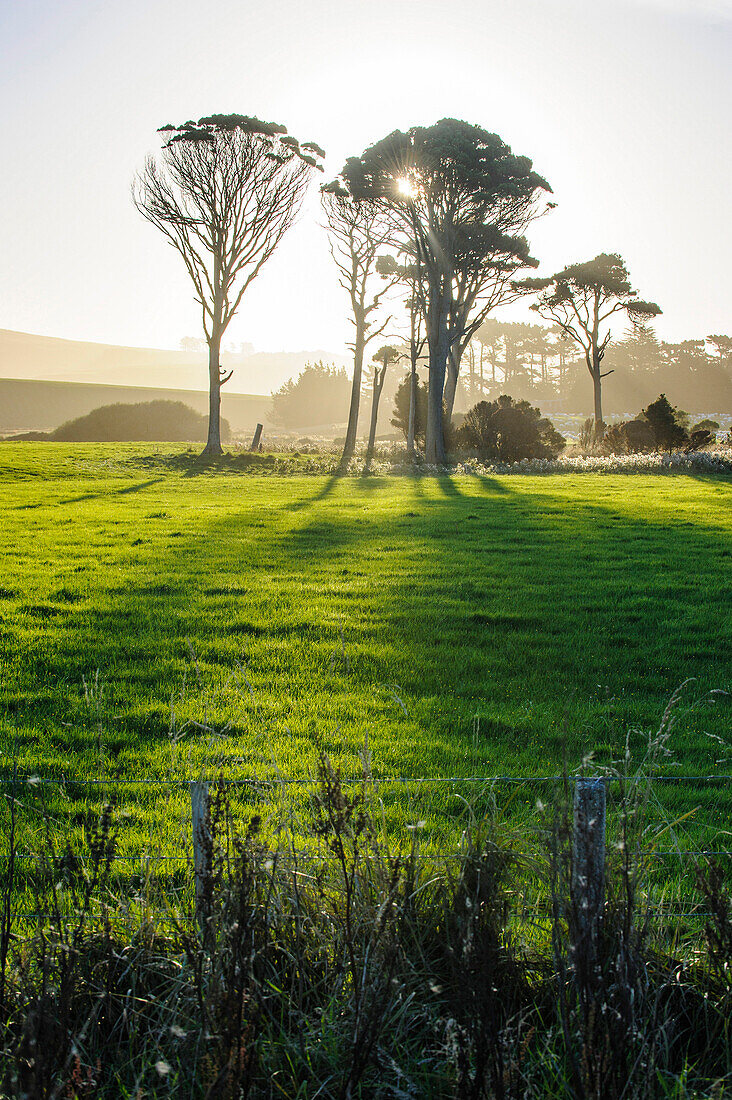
[134,114,659,457]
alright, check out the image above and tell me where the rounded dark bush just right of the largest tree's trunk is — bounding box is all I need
[457,395,565,462]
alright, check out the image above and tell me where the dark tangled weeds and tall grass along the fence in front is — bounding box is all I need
[0,765,732,1100]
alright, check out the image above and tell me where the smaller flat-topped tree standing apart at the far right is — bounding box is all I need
[518,253,660,435]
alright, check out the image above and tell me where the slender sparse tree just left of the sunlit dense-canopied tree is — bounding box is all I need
[321,182,393,470]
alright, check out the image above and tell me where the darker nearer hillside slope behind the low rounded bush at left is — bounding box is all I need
[0,378,272,436]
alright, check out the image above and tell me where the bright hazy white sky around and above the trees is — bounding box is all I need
[0,0,732,352]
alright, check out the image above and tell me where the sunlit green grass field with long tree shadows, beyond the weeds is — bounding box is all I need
[0,444,732,862]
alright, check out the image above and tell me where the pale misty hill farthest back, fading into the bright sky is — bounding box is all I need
[0,329,347,398]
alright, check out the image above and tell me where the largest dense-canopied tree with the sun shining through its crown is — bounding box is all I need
[341,119,549,464]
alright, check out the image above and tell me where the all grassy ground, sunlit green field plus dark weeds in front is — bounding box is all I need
[0,443,732,1100]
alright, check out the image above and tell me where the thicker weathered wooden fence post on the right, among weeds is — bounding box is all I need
[571,779,605,961]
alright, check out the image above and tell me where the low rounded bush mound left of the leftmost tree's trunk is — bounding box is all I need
[48,400,226,443]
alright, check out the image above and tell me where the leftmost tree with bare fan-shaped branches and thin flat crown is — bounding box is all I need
[133,114,325,454]
